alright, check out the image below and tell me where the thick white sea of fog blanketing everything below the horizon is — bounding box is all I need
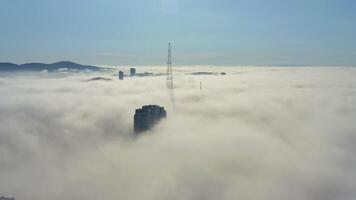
[0,67,356,200]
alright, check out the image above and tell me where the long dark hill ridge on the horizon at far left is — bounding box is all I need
[0,61,102,72]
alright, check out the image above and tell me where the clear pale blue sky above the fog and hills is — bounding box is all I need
[0,0,356,65]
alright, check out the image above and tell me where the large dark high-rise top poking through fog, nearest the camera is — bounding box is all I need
[134,105,167,133]
